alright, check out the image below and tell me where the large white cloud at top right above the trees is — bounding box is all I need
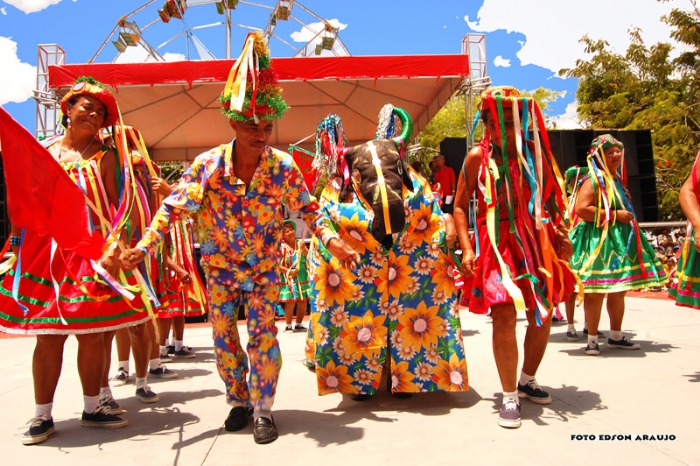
[464,0,688,72]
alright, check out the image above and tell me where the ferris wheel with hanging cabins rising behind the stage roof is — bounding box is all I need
[90,0,350,63]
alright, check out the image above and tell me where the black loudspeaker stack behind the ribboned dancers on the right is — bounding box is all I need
[440,129,659,222]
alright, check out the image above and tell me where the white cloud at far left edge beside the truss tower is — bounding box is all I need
[0,36,36,105]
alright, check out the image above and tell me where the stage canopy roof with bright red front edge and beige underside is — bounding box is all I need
[49,55,469,160]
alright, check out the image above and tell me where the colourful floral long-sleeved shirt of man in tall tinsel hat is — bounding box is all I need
[138,139,336,291]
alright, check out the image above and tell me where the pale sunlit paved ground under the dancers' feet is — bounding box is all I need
[0,298,700,466]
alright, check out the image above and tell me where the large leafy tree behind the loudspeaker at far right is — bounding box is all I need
[559,3,700,220]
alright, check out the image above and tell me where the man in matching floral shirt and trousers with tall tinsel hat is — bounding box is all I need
[122,33,357,443]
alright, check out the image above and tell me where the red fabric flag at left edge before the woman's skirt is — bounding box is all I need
[0,107,104,260]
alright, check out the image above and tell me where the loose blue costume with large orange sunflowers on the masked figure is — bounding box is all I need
[307,170,468,395]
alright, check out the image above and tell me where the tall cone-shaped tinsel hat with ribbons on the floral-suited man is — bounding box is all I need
[219,32,288,123]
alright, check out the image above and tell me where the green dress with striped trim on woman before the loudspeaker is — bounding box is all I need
[570,177,667,293]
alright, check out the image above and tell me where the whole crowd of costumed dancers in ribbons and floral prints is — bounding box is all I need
[0,30,700,445]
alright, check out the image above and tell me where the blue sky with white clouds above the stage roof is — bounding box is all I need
[0,0,693,131]
